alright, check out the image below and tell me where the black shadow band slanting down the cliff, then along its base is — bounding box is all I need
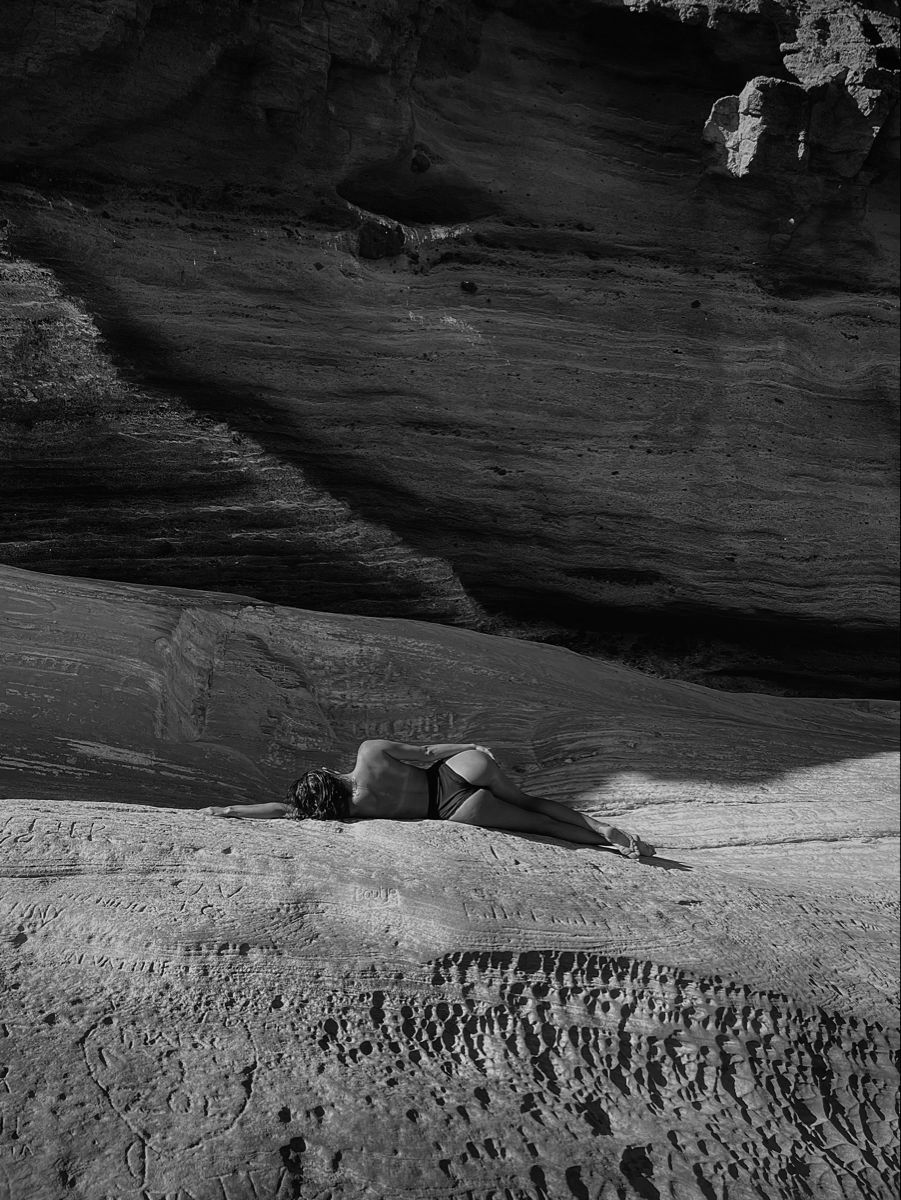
[3,208,899,698]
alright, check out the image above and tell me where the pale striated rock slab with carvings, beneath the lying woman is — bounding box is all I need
[0,569,897,1200]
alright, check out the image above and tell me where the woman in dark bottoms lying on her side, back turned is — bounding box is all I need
[203,740,655,858]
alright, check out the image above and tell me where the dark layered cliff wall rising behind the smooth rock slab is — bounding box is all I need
[0,0,897,695]
